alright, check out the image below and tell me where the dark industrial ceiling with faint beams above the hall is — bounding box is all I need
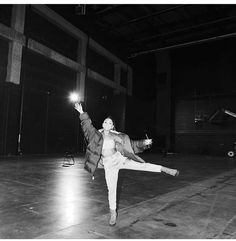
[48,4,236,58]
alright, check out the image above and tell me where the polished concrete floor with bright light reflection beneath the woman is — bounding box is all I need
[0,153,236,239]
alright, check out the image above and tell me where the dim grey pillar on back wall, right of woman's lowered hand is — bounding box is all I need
[156,51,173,151]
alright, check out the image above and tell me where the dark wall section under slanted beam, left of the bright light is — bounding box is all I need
[21,50,78,154]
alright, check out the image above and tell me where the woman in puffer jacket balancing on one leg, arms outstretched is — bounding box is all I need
[75,103,179,226]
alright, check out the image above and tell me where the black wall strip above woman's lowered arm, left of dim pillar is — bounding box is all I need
[125,55,159,147]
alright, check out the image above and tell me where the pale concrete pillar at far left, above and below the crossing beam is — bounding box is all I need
[6,4,25,85]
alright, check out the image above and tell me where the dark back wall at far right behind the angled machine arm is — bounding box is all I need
[172,38,236,155]
